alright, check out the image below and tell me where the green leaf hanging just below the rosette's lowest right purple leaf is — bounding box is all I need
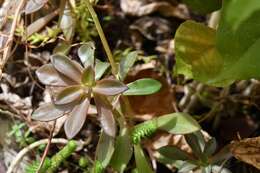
[96,131,115,168]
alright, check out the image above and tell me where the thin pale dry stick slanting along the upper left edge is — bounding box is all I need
[0,0,26,79]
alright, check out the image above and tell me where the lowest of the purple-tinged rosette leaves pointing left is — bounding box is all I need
[32,103,64,121]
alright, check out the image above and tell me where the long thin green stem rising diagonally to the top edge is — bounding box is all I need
[86,0,117,75]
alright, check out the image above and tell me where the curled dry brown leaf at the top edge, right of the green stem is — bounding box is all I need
[120,0,189,19]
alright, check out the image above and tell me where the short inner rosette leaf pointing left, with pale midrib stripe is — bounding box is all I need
[54,85,84,105]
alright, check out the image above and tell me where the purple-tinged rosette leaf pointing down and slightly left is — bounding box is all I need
[64,98,89,139]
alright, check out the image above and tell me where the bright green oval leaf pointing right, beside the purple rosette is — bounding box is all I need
[123,78,162,95]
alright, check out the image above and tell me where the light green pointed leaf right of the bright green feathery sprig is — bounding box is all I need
[157,113,201,134]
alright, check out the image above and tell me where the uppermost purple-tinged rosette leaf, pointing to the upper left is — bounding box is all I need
[51,54,82,83]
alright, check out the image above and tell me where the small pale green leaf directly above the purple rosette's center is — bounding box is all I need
[78,42,96,67]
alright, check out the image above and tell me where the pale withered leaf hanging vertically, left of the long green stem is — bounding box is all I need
[60,3,76,41]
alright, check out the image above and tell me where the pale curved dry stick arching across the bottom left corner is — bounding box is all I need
[6,138,68,173]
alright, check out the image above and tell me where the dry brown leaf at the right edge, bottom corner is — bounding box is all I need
[230,137,260,169]
